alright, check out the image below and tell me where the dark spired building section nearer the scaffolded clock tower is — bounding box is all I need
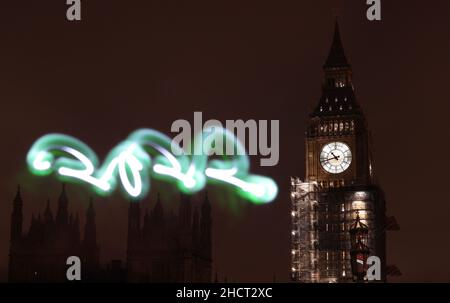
[127,195,212,282]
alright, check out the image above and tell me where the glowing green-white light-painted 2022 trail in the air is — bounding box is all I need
[27,128,278,204]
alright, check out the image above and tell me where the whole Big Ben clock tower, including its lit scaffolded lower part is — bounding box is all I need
[291,22,386,282]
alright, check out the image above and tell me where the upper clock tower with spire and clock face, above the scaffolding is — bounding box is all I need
[305,23,372,188]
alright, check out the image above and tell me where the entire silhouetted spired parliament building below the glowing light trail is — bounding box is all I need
[9,187,212,282]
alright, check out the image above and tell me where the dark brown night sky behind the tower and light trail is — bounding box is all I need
[0,0,450,282]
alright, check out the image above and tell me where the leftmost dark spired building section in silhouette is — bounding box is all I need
[9,186,99,282]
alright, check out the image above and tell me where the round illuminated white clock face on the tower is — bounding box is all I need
[320,142,352,174]
